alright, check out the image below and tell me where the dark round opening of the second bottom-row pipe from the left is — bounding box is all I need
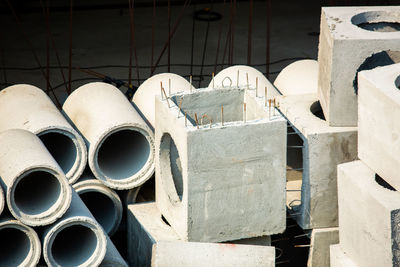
[51,225,97,266]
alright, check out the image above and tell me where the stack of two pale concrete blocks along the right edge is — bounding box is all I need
[331,64,400,267]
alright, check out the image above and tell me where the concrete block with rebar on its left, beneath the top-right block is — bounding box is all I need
[278,94,357,229]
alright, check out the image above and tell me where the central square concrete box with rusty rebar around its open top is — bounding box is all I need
[155,87,286,242]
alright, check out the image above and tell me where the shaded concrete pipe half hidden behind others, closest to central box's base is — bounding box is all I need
[72,177,123,236]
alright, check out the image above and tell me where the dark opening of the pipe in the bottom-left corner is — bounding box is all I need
[0,227,31,266]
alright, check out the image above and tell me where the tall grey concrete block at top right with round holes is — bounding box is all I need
[318,6,400,126]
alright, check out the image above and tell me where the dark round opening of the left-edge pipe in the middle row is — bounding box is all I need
[14,171,61,218]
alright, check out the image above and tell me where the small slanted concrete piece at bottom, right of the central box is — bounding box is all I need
[307,227,339,267]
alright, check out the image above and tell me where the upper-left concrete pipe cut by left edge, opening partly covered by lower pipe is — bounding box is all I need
[0,84,87,184]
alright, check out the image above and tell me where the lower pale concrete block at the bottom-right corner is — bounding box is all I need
[338,161,400,267]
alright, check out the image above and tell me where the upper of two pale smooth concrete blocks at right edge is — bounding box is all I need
[358,64,400,193]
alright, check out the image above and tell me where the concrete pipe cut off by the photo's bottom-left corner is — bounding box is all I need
[0,217,41,267]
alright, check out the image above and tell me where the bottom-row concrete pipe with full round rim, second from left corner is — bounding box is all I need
[42,190,107,267]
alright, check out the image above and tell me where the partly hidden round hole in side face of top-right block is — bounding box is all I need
[353,50,400,95]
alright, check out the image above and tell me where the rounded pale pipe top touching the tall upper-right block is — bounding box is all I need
[274,59,318,95]
